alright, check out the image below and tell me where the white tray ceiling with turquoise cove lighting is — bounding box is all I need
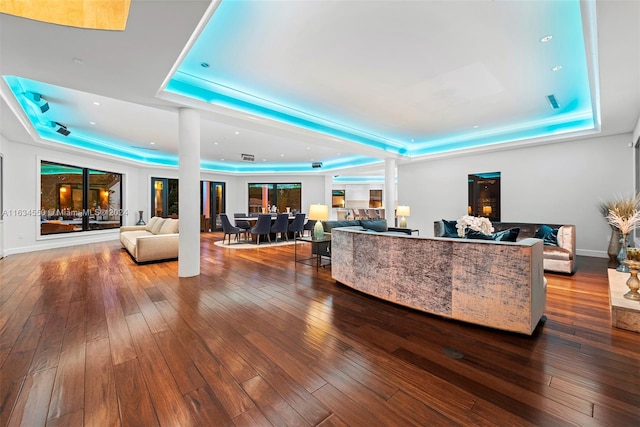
[0,0,640,175]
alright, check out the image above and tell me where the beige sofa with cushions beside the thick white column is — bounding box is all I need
[120,216,179,262]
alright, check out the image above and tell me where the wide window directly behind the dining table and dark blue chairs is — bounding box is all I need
[249,182,302,213]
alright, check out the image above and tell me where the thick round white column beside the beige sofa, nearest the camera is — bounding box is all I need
[178,108,200,277]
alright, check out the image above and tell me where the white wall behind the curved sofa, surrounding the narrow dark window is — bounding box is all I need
[398,133,634,257]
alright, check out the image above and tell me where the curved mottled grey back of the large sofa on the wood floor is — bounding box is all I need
[331,228,546,335]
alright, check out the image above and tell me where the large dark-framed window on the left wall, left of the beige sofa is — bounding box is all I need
[40,161,123,235]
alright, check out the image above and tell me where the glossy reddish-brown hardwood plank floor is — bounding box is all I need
[0,233,640,426]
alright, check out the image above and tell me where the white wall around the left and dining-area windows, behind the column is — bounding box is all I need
[0,138,331,255]
